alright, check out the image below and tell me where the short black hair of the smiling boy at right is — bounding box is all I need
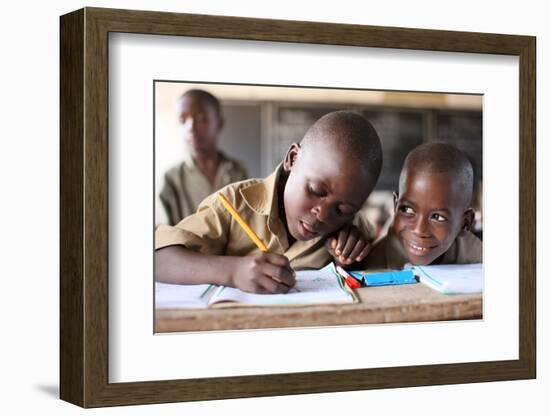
[399,142,474,205]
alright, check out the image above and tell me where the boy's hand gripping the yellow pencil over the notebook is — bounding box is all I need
[231,253,296,293]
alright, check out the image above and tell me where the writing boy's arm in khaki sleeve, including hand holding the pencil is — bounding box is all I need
[155,187,296,293]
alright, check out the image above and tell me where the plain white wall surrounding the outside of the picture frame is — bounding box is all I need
[0,0,550,415]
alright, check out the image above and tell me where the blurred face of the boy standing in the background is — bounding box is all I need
[178,95,223,153]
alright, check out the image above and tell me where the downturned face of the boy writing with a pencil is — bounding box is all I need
[283,143,375,241]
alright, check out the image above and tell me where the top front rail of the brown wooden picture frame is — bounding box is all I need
[86,8,529,55]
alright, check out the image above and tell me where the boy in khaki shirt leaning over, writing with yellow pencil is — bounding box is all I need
[155,111,382,293]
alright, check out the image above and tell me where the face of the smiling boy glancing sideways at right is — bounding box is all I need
[393,169,473,265]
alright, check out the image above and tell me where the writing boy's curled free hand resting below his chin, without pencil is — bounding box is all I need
[326,225,371,265]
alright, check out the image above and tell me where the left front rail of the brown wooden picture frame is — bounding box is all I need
[84,9,109,406]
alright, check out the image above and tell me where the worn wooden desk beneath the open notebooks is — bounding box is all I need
[155,283,482,332]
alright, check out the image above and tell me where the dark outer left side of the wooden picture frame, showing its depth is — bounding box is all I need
[59,11,86,406]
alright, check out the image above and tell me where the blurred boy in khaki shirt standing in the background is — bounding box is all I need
[157,89,248,225]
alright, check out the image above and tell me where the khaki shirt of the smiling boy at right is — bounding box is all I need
[363,228,483,270]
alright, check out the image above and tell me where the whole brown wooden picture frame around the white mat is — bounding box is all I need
[60,8,536,407]
